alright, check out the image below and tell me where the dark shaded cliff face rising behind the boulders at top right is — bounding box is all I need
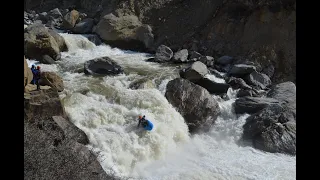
[25,0,296,82]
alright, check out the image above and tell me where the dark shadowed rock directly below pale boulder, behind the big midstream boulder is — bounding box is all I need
[195,78,230,94]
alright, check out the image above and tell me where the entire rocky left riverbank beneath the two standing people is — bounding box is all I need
[24,56,116,179]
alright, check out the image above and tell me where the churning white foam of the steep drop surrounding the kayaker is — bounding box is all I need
[64,87,189,175]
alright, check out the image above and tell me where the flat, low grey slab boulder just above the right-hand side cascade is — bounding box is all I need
[234,97,280,114]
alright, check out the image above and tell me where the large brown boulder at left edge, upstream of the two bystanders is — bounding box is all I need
[24,23,61,60]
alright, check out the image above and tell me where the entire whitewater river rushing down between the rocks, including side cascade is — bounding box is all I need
[28,33,296,180]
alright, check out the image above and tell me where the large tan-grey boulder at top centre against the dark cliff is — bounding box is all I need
[94,13,153,50]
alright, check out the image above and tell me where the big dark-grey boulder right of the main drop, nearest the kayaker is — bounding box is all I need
[165,78,220,133]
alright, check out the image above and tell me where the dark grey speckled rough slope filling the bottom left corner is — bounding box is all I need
[24,120,112,180]
